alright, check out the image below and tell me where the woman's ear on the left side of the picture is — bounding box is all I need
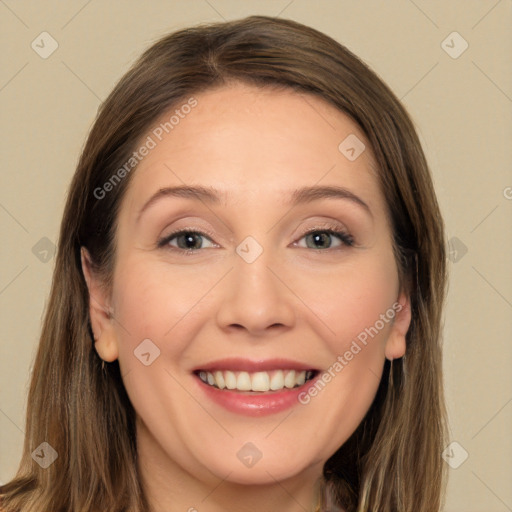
[80,247,119,362]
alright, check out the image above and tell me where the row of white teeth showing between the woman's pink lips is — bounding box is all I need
[194,370,319,393]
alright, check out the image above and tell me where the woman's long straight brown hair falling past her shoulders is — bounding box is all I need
[0,16,446,512]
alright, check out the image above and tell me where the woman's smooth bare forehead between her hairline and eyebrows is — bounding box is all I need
[120,83,385,218]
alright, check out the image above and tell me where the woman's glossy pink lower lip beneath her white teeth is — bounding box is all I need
[194,375,318,416]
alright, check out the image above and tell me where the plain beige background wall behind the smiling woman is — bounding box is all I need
[0,0,512,512]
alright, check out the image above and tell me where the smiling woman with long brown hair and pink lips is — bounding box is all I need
[0,16,446,512]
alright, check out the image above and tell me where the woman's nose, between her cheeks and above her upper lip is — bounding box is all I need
[217,251,296,337]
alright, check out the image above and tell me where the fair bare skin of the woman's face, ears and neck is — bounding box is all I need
[82,83,410,512]
